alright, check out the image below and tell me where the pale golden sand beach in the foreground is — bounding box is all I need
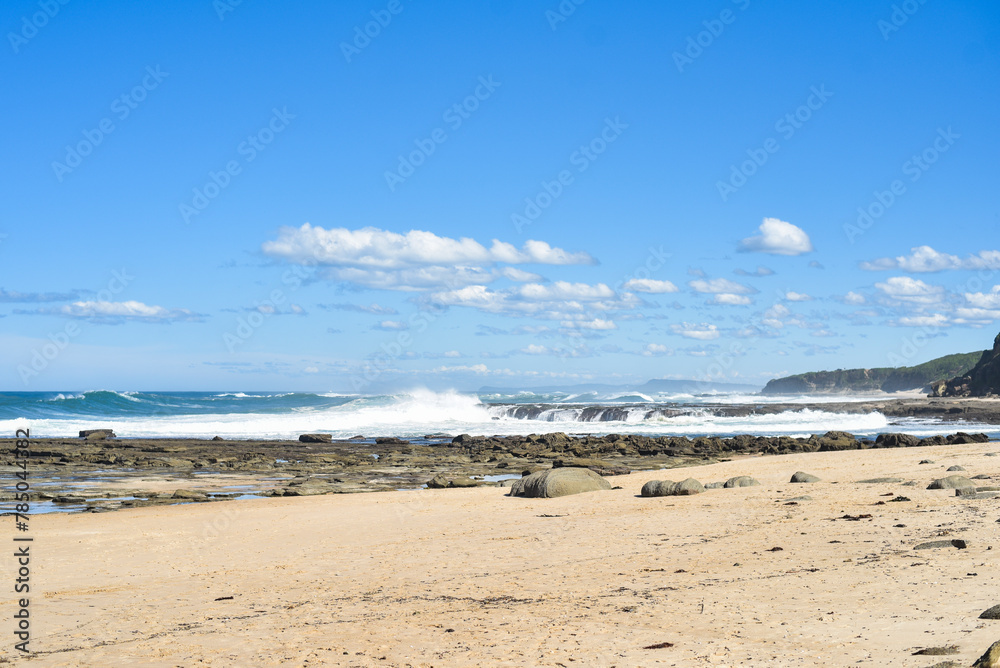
[7,443,1000,667]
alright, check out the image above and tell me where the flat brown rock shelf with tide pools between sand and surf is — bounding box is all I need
[0,429,988,508]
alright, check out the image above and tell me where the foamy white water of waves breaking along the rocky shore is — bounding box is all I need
[0,389,997,439]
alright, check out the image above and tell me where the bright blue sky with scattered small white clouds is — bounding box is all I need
[0,0,1000,392]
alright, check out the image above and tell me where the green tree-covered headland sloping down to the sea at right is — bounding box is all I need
[761,351,983,394]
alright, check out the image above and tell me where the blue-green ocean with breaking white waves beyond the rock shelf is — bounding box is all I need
[0,389,1000,439]
